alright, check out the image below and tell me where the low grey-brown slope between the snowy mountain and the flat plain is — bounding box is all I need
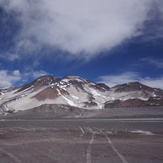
[3,104,163,120]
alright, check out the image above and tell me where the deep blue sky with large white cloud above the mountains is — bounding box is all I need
[0,0,163,89]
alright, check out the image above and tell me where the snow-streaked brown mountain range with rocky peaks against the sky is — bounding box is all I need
[0,75,163,114]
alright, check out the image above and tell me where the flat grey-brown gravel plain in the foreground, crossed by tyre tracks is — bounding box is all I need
[0,119,163,163]
